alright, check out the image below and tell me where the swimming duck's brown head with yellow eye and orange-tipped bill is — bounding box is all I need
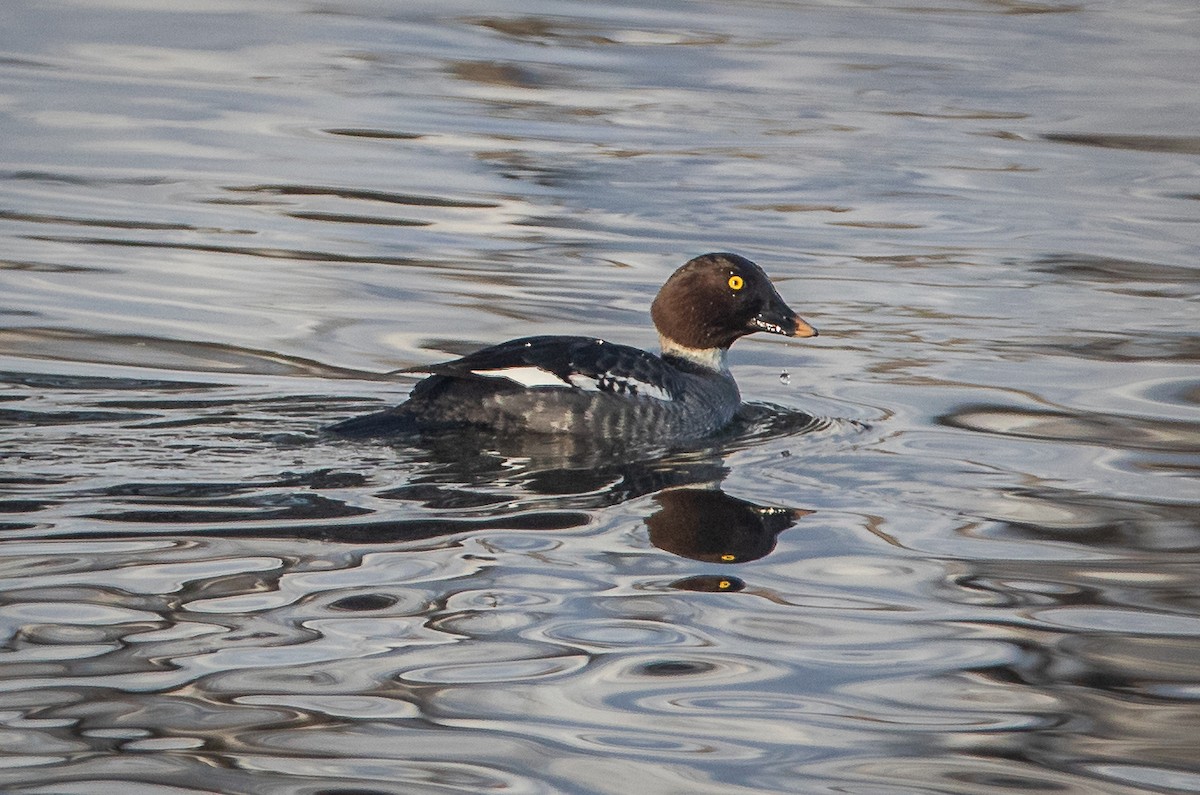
[650,253,817,351]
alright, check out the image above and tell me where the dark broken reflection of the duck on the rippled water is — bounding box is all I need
[350,405,820,566]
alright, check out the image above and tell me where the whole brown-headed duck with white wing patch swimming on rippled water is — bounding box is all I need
[326,252,817,443]
